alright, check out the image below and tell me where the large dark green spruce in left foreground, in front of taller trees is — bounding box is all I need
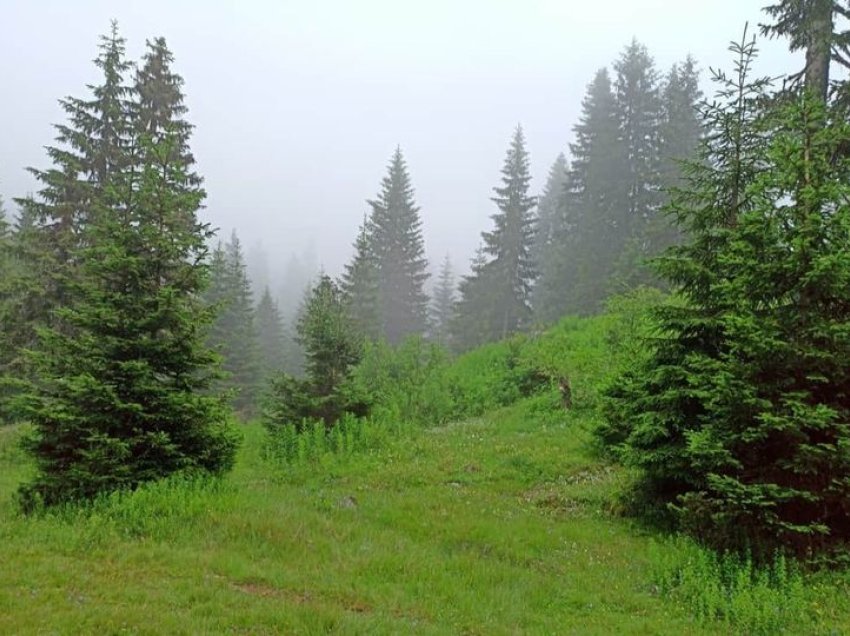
[21,134,242,507]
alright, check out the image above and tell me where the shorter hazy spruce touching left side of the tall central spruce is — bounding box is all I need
[340,218,381,339]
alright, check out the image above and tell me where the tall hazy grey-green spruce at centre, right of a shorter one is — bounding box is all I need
[369,148,428,344]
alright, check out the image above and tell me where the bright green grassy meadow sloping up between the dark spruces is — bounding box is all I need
[0,312,850,634]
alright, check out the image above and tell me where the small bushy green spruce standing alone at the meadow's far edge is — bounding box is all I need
[263,275,363,436]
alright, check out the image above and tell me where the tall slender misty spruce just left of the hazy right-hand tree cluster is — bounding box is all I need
[453,126,537,348]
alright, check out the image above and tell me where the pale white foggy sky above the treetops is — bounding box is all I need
[0,0,795,284]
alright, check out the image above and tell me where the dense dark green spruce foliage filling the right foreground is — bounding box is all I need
[600,32,850,555]
